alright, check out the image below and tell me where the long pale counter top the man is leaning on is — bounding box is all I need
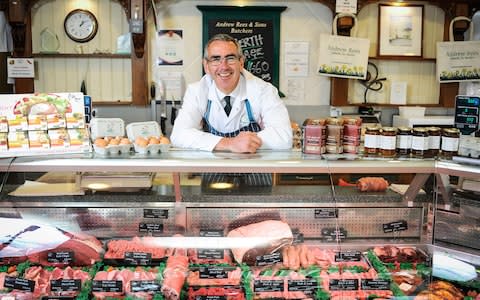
[0,149,444,174]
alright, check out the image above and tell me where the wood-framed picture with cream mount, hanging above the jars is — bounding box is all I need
[378,4,423,57]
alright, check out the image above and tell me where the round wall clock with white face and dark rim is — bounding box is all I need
[63,9,98,43]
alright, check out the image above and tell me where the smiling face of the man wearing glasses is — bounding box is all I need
[203,41,244,94]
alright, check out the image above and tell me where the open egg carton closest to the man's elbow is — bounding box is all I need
[126,121,170,154]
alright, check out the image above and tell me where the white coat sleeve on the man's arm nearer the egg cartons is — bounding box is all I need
[170,83,222,151]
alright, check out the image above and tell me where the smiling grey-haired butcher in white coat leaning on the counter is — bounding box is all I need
[171,34,292,153]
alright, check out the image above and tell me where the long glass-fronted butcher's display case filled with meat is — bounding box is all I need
[0,149,480,300]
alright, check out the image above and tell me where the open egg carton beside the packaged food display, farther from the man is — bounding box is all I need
[90,118,132,155]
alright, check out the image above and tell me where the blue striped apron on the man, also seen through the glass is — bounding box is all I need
[202,99,272,186]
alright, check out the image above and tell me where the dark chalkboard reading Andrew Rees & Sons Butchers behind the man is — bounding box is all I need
[197,6,286,88]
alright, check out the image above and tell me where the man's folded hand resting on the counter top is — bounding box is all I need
[215,131,262,153]
